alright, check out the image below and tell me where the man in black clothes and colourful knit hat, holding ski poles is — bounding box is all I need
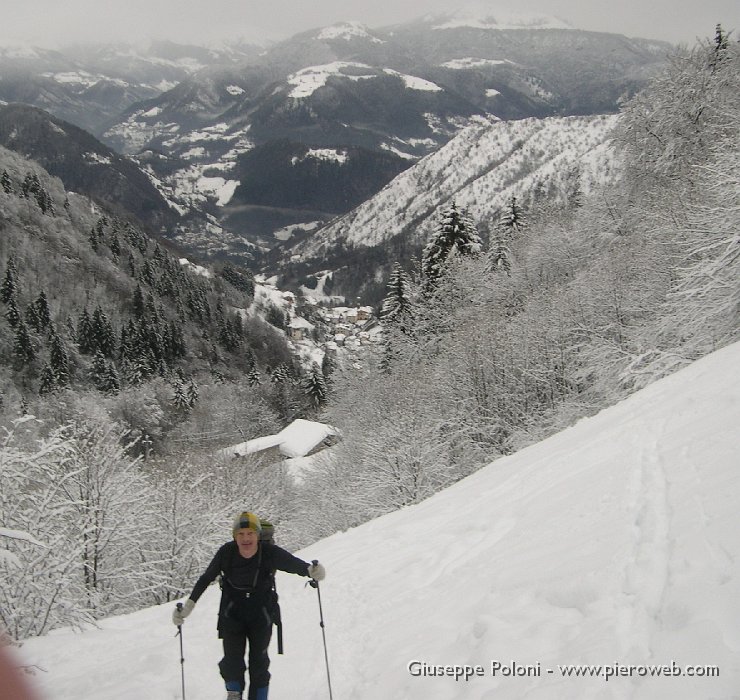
[172,512,326,700]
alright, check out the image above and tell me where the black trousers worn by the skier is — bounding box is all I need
[218,608,272,700]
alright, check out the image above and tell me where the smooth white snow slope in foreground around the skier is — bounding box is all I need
[17,344,740,700]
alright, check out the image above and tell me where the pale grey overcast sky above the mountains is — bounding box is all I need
[0,0,740,46]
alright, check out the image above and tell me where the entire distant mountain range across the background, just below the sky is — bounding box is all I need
[0,15,670,274]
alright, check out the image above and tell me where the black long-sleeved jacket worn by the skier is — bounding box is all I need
[190,540,309,633]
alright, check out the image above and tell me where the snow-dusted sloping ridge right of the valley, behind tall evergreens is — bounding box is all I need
[272,109,618,296]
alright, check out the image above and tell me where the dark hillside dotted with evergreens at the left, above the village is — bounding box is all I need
[0,144,300,427]
